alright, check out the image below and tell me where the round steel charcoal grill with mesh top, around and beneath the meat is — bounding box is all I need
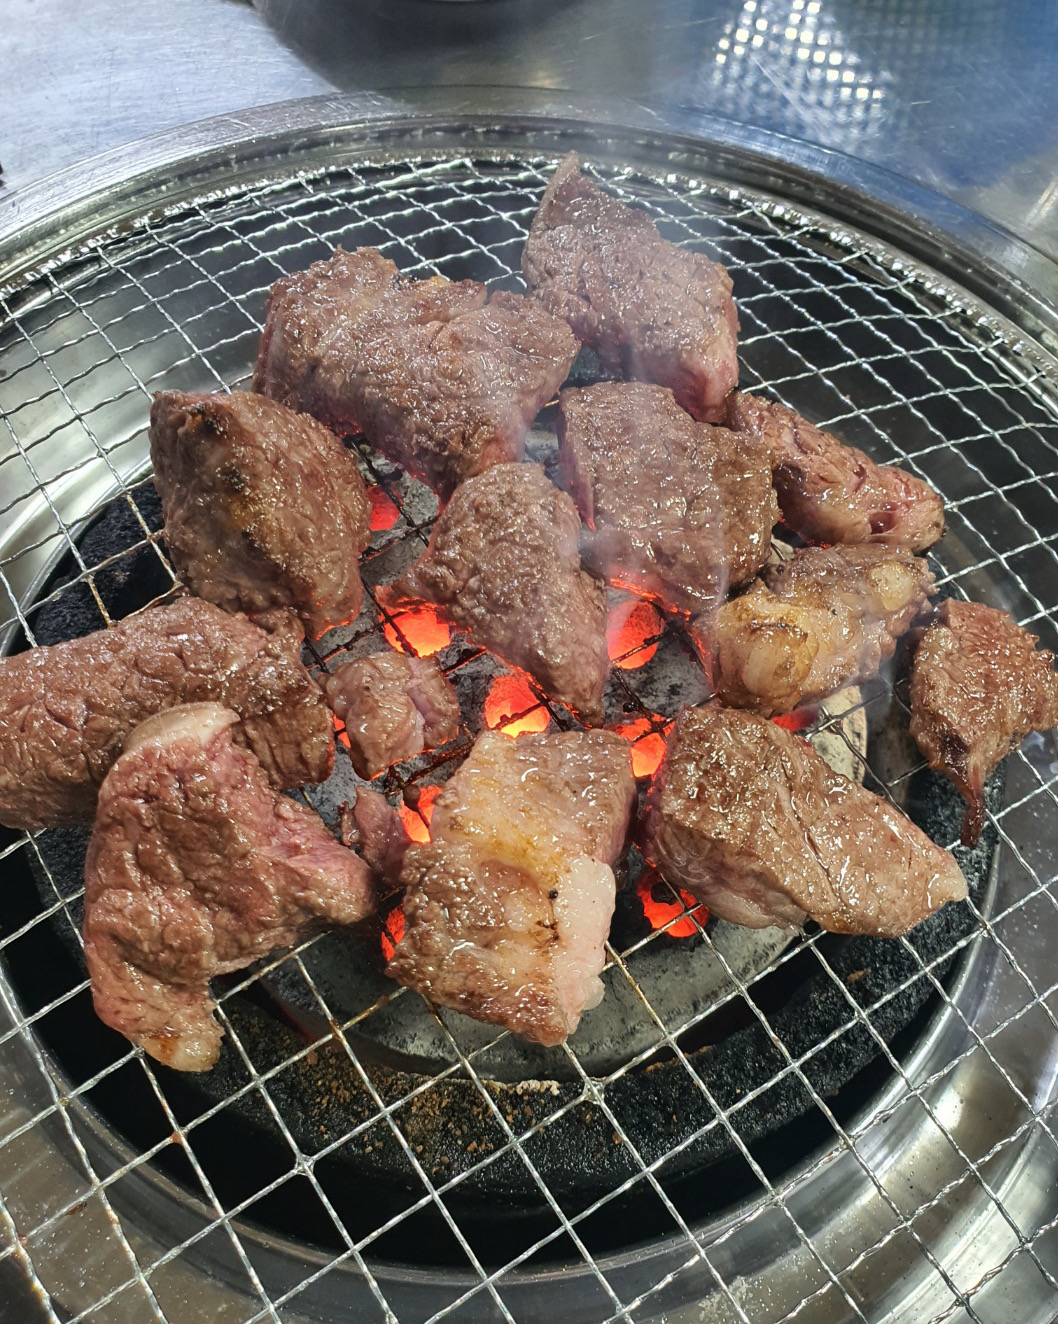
[0,94,1058,1324]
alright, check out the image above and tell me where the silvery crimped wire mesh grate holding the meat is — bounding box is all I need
[0,155,1058,1324]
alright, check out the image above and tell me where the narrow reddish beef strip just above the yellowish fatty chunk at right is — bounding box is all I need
[727,392,944,552]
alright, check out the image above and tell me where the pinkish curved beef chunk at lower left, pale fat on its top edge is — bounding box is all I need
[85,703,375,1071]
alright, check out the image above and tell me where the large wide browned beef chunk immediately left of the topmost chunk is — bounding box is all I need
[253,248,577,499]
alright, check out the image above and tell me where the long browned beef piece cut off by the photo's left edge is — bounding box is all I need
[0,597,334,830]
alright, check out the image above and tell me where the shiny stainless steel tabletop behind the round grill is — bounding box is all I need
[0,0,1058,257]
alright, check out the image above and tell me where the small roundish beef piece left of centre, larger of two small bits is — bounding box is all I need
[323,651,459,777]
